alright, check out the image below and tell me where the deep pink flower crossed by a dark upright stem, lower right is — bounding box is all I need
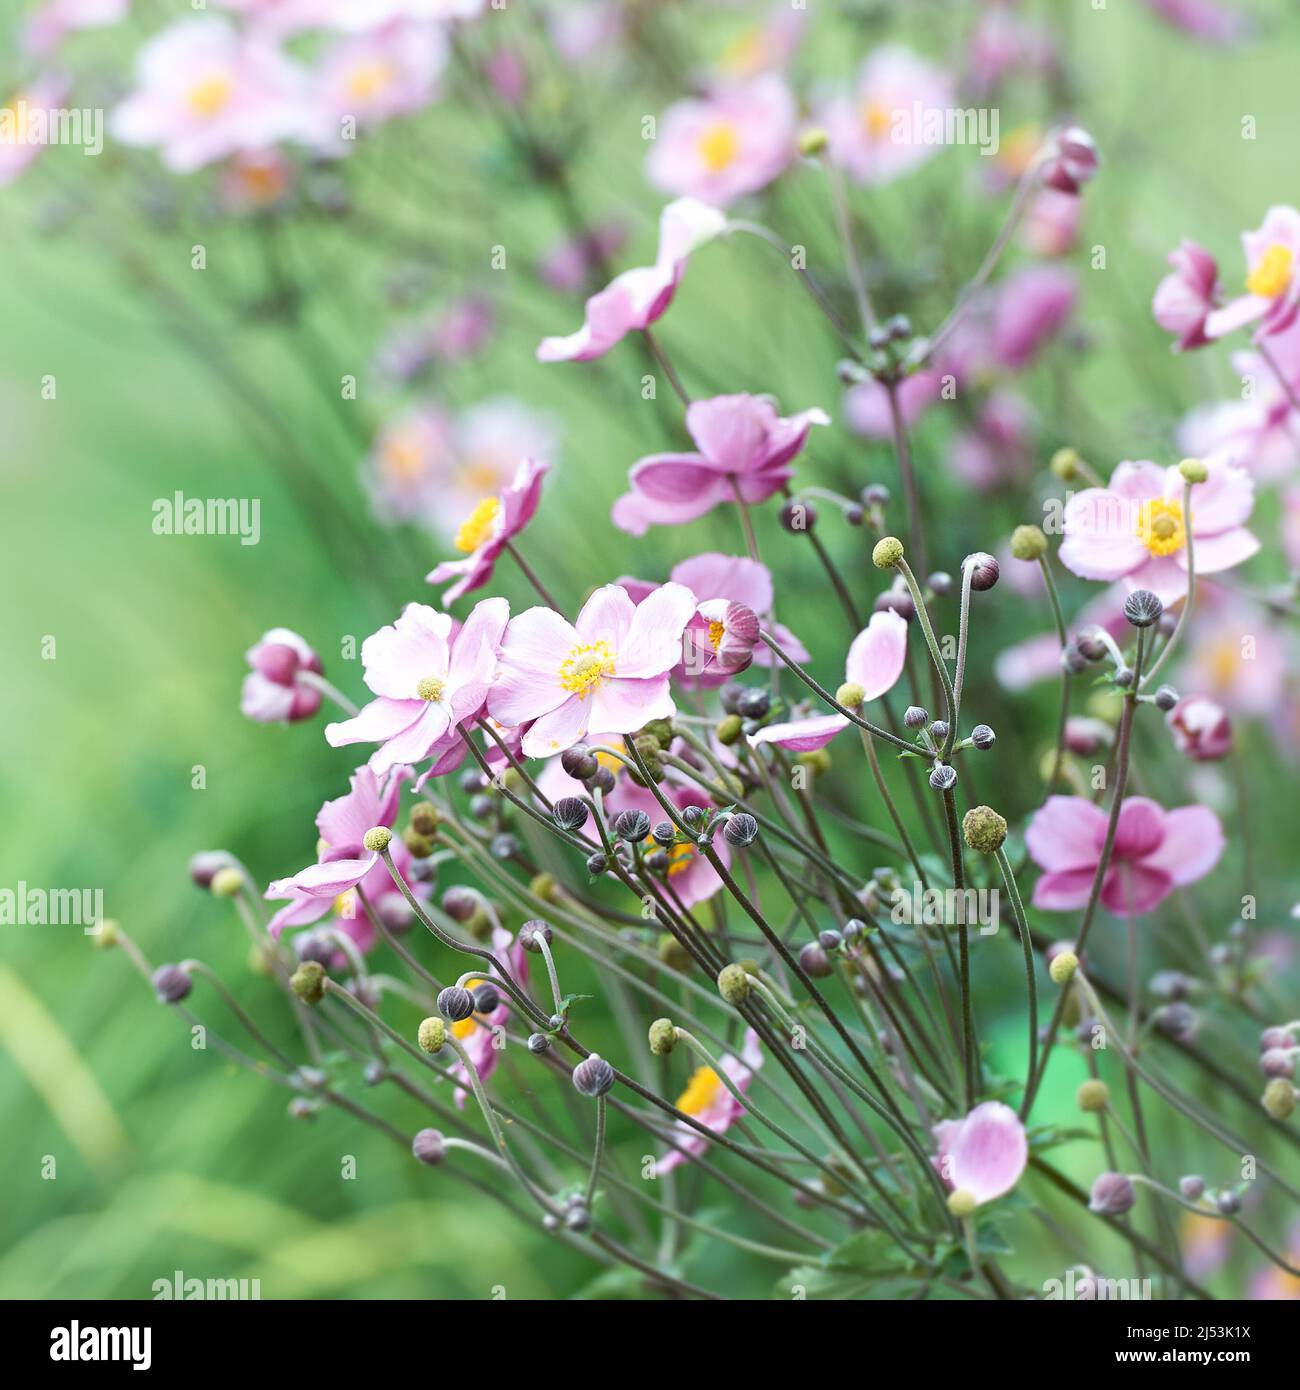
[1025,796,1224,916]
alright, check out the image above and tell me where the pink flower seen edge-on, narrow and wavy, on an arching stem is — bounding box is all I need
[537,197,727,361]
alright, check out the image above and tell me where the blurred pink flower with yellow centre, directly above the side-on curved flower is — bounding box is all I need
[647,74,797,207]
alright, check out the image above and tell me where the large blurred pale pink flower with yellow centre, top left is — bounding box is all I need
[110,18,328,174]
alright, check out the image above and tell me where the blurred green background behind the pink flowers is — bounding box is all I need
[0,0,1300,1298]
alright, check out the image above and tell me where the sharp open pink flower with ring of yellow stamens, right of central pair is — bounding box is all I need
[488,584,695,758]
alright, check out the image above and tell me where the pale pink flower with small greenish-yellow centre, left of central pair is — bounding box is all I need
[325,599,510,773]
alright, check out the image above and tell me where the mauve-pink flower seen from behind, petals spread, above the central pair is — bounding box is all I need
[613,395,830,535]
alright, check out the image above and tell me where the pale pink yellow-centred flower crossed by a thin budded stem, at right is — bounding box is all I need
[1061,459,1260,603]
